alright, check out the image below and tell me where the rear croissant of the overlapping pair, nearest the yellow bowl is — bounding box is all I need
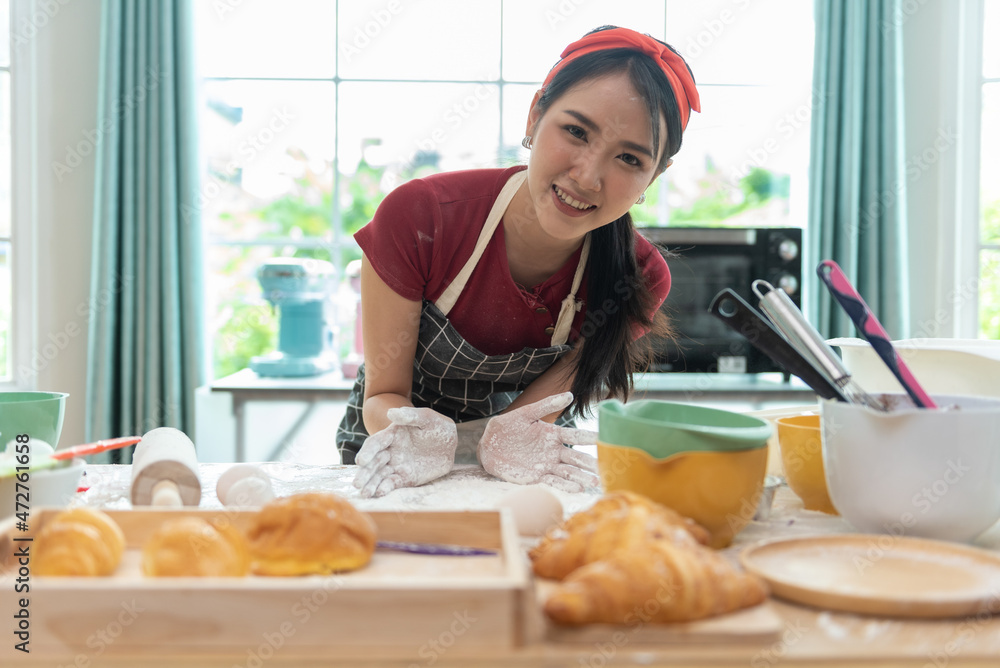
[529,491,709,580]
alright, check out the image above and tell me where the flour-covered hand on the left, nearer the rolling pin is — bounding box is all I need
[354,406,458,497]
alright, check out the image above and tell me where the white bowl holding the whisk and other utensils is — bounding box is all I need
[820,394,1000,542]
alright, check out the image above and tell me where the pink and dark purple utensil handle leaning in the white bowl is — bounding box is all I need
[816,260,937,408]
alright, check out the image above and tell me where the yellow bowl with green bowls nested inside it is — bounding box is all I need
[597,441,767,548]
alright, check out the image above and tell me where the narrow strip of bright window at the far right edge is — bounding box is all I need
[978,0,1000,339]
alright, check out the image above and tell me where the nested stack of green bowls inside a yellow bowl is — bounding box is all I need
[597,400,773,548]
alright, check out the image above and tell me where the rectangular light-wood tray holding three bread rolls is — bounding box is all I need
[0,509,534,662]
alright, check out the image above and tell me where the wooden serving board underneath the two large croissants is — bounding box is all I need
[534,579,785,647]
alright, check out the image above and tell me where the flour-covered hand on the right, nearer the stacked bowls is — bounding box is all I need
[479,392,598,492]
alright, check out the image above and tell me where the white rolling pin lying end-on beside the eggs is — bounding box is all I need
[132,427,201,507]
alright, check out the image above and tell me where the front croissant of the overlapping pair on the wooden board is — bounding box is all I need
[544,540,767,626]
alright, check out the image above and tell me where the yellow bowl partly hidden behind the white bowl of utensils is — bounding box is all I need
[775,415,838,515]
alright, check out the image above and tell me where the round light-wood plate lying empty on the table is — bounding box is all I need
[740,534,1000,617]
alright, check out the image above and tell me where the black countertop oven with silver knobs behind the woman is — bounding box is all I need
[639,227,802,376]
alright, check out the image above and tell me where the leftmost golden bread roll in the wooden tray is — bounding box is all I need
[32,508,125,576]
